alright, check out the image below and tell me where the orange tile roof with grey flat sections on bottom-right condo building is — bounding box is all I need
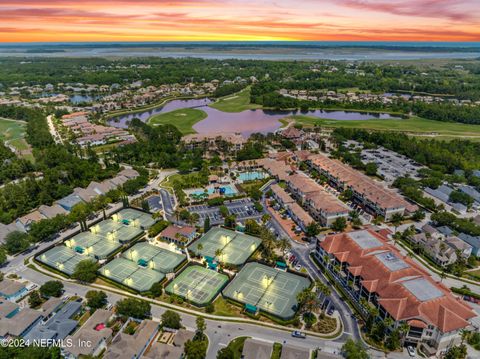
[320,230,475,333]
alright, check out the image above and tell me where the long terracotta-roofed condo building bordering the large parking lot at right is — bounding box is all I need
[306,154,417,221]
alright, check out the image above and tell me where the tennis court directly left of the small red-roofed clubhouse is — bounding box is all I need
[122,242,186,273]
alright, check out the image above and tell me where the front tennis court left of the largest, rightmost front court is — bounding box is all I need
[165,266,228,306]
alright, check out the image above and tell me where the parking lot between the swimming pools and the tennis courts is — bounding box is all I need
[188,198,263,225]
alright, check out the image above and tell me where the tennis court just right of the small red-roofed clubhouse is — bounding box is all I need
[189,227,262,265]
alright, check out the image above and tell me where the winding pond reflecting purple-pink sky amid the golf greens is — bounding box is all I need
[108,99,399,136]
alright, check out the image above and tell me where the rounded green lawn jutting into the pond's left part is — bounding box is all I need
[148,108,207,135]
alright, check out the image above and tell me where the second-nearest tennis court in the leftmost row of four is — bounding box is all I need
[64,232,121,259]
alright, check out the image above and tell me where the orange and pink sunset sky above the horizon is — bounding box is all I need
[0,0,480,42]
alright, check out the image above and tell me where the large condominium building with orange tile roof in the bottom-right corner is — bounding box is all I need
[315,230,476,356]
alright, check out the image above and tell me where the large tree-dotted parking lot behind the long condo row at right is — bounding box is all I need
[361,147,423,183]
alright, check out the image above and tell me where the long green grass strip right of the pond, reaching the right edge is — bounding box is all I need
[282,115,480,141]
